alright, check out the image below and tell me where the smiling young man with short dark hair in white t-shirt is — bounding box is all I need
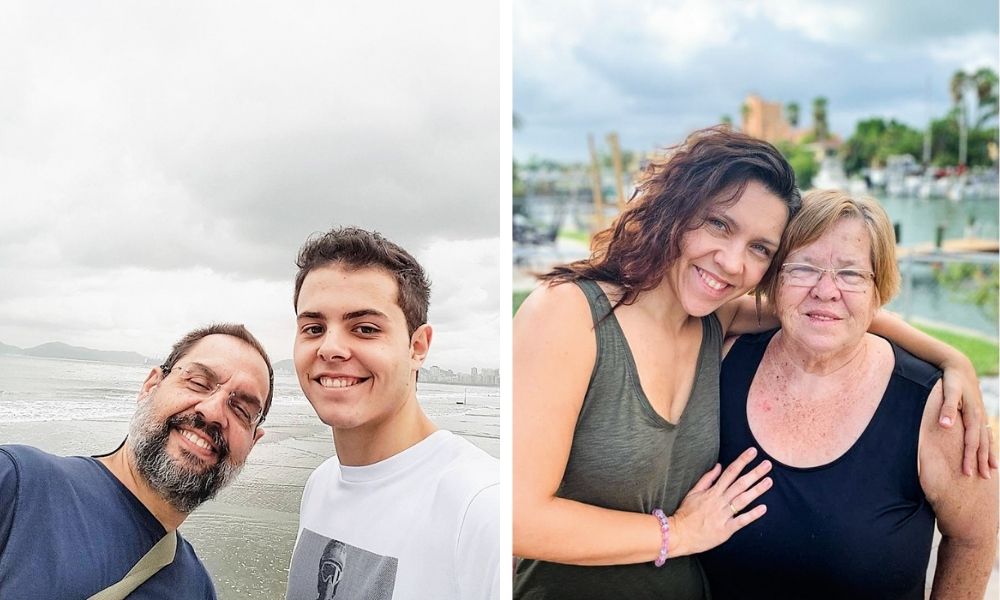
[287,228,503,600]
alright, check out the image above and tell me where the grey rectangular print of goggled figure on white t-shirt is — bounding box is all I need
[285,529,399,600]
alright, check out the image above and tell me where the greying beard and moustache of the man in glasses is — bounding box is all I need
[128,396,243,513]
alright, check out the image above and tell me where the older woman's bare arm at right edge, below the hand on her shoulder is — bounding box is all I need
[918,381,998,598]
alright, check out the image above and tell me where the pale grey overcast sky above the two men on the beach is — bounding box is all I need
[0,1,500,370]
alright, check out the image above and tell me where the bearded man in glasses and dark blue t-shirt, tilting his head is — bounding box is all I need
[0,324,274,600]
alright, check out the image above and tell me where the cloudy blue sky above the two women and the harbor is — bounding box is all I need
[513,0,998,160]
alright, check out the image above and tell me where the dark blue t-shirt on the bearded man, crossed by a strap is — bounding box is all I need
[0,445,216,600]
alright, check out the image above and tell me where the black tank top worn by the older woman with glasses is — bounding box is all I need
[702,331,941,600]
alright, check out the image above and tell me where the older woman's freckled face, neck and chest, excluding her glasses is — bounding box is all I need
[747,219,894,467]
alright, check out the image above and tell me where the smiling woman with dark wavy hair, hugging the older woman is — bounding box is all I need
[513,128,988,599]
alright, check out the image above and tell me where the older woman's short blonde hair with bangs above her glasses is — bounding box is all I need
[764,190,899,306]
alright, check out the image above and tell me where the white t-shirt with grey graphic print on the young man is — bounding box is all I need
[286,430,500,600]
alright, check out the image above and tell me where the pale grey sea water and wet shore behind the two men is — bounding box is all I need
[0,355,500,600]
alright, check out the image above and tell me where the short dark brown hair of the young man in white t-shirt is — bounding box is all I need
[293,227,431,335]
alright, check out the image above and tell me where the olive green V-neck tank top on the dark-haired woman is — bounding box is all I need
[514,280,722,600]
